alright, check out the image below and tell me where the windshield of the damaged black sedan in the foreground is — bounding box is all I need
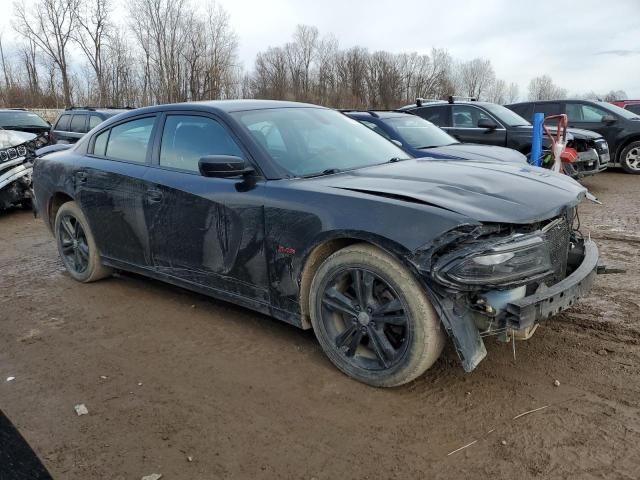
[233,108,407,177]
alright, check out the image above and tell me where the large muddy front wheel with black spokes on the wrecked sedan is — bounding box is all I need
[309,244,445,387]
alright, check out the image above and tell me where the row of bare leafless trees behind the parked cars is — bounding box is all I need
[0,0,626,109]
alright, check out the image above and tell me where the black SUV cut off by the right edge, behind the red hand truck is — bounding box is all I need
[507,100,640,174]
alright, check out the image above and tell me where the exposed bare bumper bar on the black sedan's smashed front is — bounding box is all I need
[506,240,598,330]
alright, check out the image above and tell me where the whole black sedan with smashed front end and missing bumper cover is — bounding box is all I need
[34,100,598,386]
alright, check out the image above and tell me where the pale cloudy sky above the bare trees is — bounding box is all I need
[0,0,640,98]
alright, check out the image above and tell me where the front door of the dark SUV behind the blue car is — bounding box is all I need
[444,103,507,146]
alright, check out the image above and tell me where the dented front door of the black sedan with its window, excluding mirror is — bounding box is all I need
[145,112,269,303]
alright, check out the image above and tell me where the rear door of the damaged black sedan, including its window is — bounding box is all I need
[74,115,157,267]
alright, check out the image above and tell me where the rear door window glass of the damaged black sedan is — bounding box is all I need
[106,117,155,163]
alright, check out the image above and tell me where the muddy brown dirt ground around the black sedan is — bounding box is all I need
[0,172,640,480]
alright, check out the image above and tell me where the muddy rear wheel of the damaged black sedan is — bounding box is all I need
[54,202,112,283]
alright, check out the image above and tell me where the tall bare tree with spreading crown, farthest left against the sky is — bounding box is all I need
[14,0,78,105]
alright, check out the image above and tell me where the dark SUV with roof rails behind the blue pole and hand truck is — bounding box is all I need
[402,98,609,176]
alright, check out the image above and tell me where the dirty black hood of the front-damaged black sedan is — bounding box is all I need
[306,158,586,224]
